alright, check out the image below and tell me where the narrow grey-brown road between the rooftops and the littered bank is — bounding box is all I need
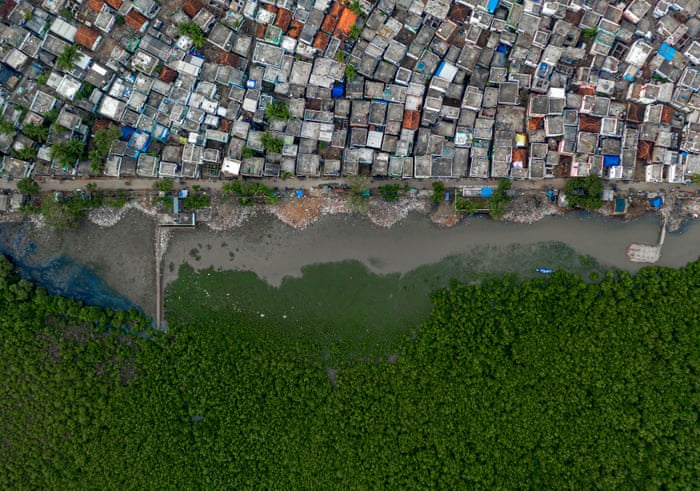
[0,174,698,193]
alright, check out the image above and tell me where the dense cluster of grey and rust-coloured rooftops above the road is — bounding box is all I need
[0,0,700,182]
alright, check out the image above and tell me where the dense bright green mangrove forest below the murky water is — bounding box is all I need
[0,250,700,489]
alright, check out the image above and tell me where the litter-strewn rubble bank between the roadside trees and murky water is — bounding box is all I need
[0,187,688,234]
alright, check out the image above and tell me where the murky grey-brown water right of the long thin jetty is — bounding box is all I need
[164,215,700,285]
